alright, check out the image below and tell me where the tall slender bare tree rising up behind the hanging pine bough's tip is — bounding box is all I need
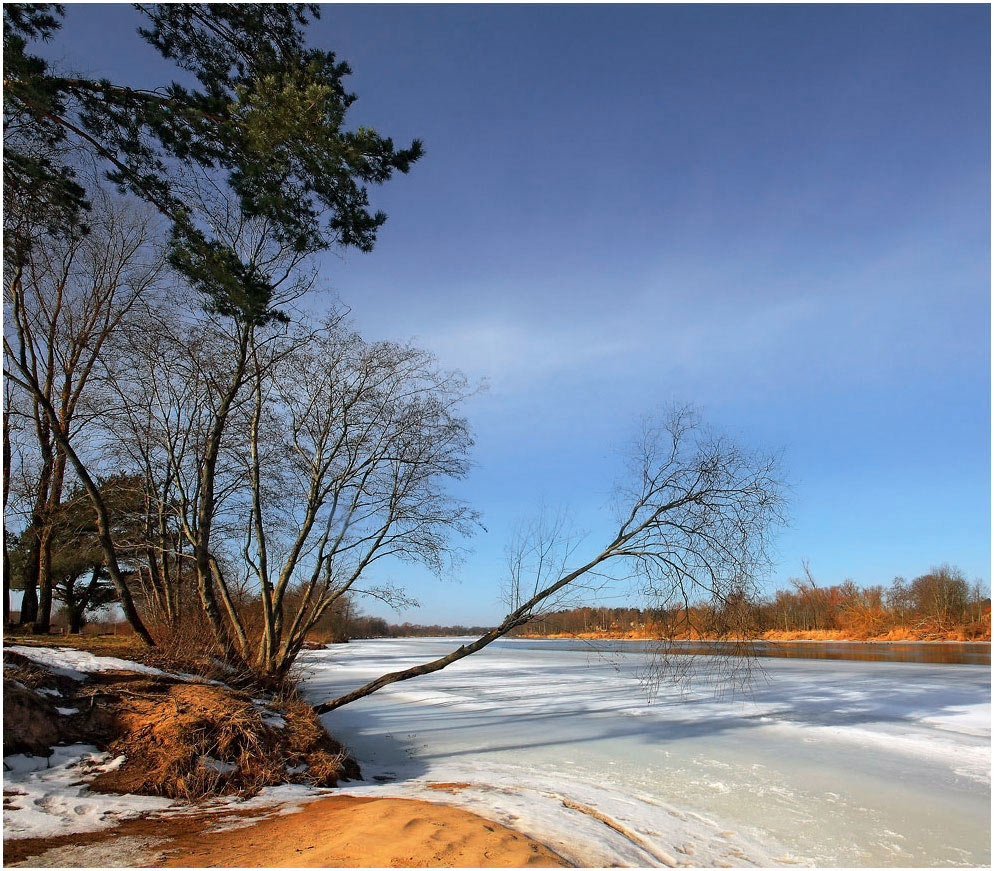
[96,186,314,662]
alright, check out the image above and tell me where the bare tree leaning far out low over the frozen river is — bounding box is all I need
[315,408,785,714]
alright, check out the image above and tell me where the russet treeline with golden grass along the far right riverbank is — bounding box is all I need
[517,565,991,640]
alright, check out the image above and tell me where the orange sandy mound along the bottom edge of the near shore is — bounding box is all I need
[4,796,567,868]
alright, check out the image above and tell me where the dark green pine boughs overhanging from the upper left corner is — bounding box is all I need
[4,3,422,321]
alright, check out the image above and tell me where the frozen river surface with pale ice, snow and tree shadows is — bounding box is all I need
[303,638,991,866]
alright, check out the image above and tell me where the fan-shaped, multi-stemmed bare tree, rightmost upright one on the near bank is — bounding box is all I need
[243,318,476,674]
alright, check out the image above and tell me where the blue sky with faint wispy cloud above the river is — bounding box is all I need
[42,5,991,622]
